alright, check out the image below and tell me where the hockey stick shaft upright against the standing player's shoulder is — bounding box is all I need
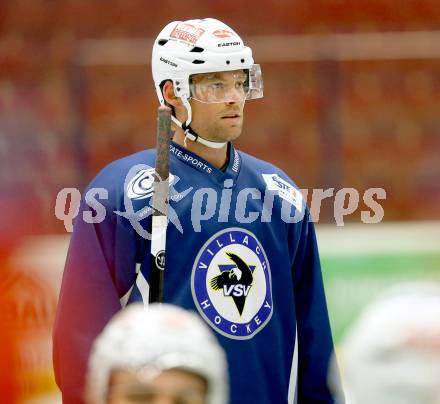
[149,106,171,303]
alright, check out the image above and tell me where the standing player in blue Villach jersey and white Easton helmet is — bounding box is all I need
[54,18,344,404]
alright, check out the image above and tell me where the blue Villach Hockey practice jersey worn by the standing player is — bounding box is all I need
[54,143,344,404]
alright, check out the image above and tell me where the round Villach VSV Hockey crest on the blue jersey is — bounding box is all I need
[191,227,273,339]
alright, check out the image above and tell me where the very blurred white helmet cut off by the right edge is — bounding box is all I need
[341,282,440,404]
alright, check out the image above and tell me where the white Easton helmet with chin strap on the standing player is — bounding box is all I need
[151,18,263,148]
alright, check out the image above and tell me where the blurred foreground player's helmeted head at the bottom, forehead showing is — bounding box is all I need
[86,303,227,404]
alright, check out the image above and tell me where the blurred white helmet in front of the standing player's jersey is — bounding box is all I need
[86,303,228,404]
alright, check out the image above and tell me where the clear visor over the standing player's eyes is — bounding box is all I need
[189,65,263,104]
